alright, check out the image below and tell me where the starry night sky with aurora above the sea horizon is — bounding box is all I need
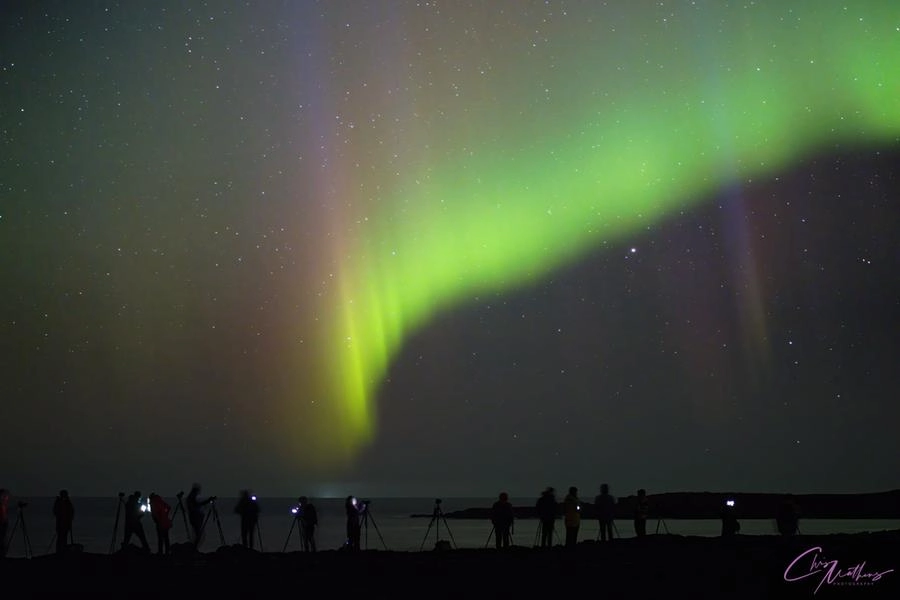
[0,0,900,496]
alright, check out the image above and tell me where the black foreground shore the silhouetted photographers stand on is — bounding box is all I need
[0,531,900,600]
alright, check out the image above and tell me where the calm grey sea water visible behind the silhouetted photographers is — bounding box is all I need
[8,497,900,557]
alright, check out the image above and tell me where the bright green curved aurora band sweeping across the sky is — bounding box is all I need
[284,2,900,460]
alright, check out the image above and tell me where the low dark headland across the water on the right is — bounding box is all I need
[424,490,900,519]
